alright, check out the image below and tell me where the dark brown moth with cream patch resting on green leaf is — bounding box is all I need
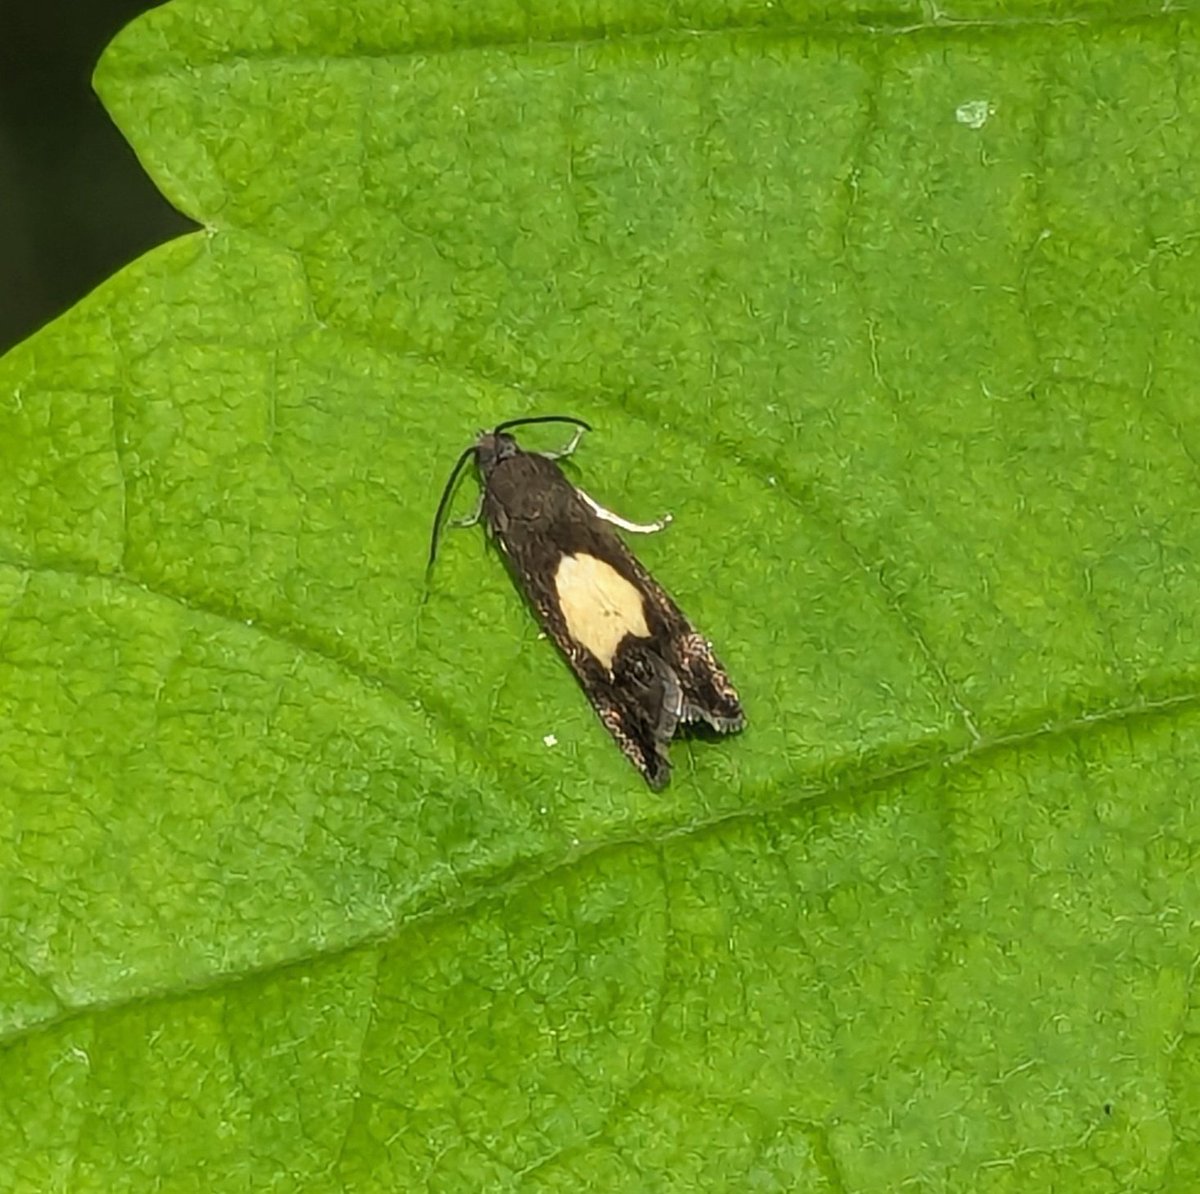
[430,415,745,791]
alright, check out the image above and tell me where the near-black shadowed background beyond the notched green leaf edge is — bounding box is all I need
[0,0,194,354]
